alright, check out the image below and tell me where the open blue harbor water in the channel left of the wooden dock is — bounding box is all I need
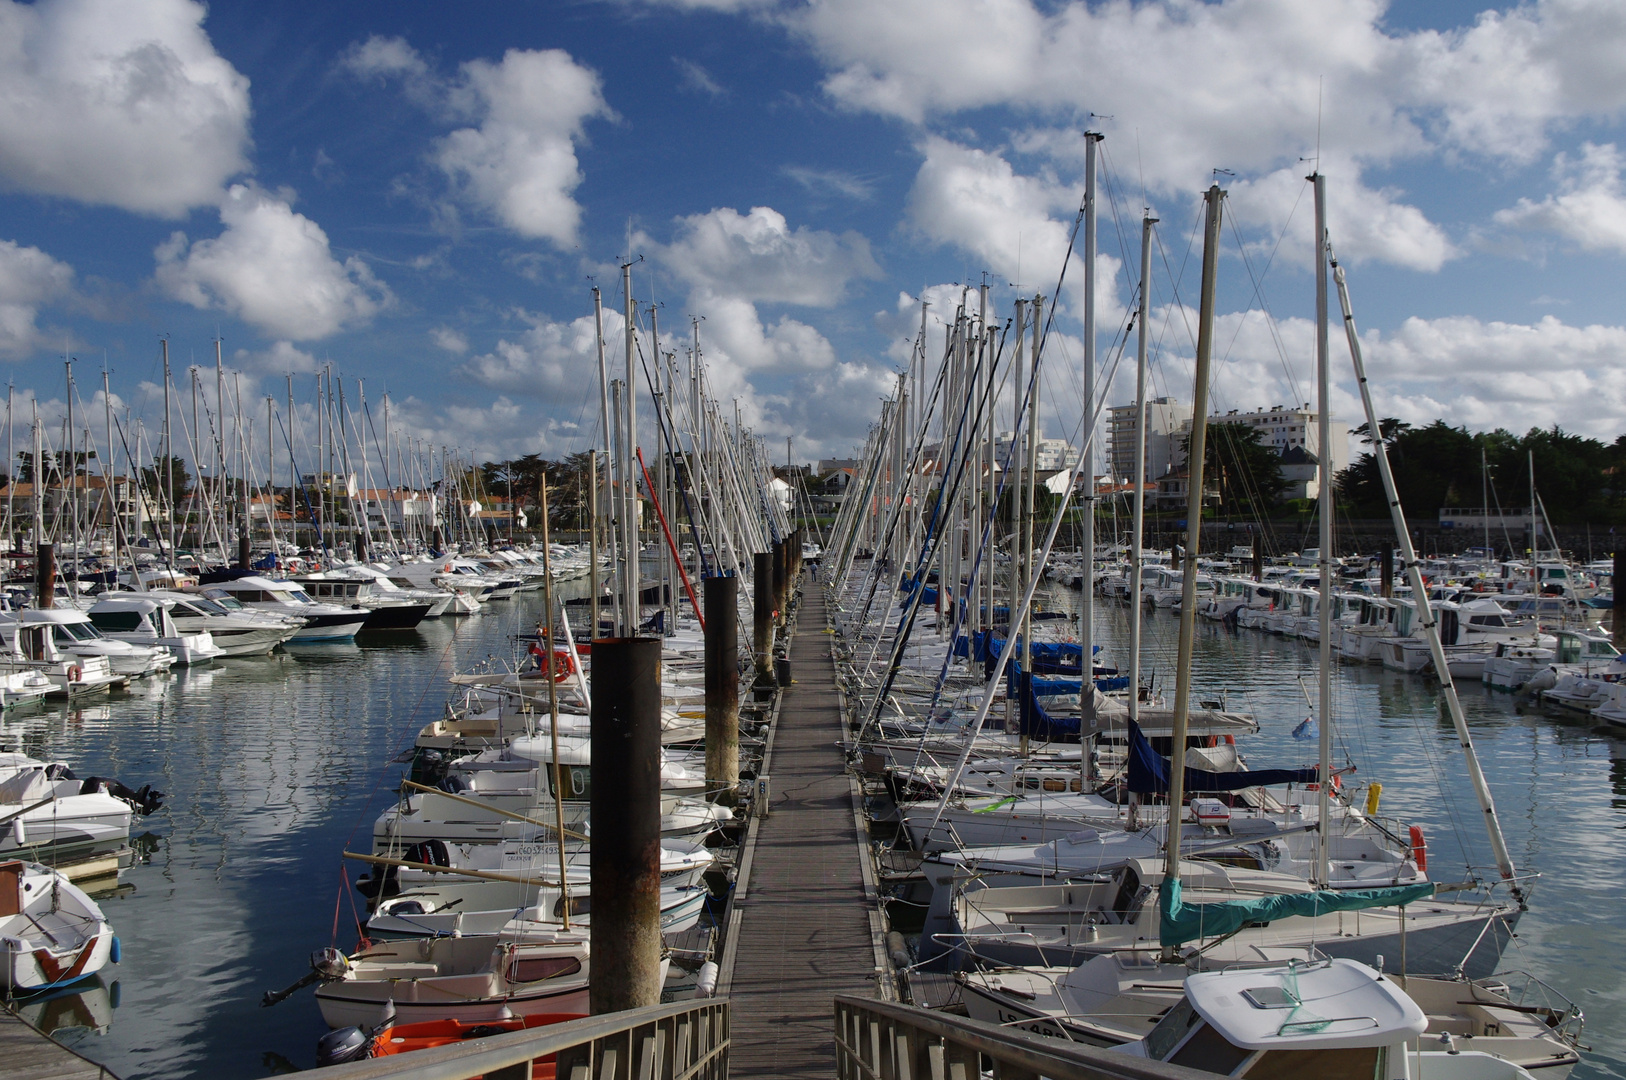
[0,586,569,1080]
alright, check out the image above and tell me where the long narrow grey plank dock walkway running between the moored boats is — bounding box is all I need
[719,582,878,1080]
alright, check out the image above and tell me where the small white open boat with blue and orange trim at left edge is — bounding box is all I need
[0,860,119,994]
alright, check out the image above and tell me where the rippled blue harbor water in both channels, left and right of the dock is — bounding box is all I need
[12,582,1626,1078]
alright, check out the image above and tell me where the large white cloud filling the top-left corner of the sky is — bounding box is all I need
[0,0,249,218]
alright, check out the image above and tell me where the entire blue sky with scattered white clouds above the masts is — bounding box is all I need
[0,0,1626,474]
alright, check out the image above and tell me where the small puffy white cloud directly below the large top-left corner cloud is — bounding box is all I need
[154,184,393,342]
